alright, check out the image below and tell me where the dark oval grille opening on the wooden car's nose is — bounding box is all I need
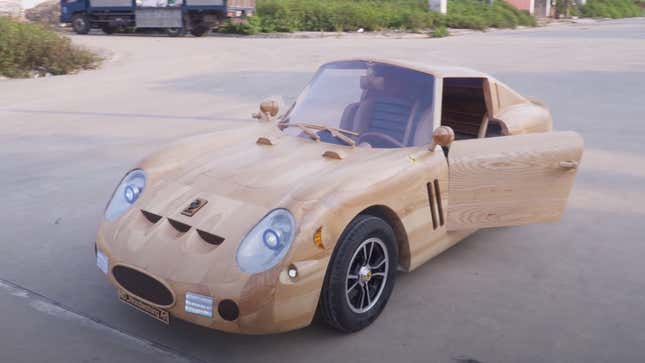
[112,265,174,306]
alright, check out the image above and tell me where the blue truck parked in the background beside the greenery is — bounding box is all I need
[60,0,255,37]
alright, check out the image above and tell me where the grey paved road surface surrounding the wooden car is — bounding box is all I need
[0,19,645,363]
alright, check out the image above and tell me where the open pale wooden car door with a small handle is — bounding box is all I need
[446,132,583,231]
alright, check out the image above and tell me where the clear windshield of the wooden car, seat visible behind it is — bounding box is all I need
[282,61,434,148]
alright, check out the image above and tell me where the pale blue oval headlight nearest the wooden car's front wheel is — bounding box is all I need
[237,209,296,273]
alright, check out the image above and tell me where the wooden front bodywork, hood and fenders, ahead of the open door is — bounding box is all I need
[97,122,448,334]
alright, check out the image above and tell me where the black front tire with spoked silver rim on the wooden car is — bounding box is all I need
[319,215,399,333]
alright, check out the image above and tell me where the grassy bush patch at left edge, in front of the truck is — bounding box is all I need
[0,17,100,78]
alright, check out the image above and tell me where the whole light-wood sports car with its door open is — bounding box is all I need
[96,59,583,334]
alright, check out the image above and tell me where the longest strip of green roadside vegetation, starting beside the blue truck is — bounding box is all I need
[222,0,536,36]
